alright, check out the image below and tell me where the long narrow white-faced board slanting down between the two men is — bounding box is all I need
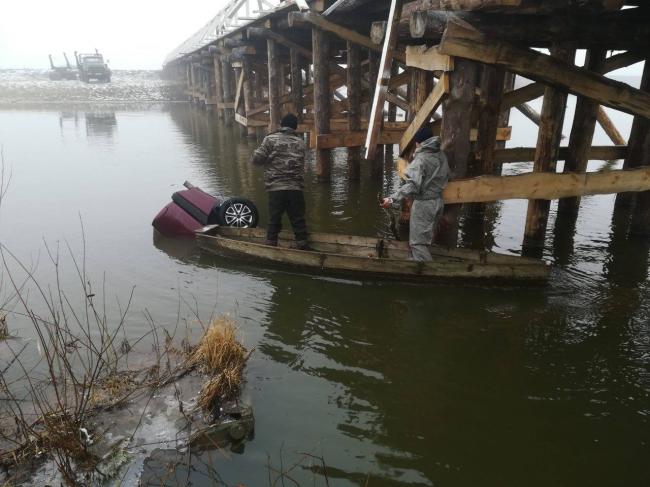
[364,0,403,159]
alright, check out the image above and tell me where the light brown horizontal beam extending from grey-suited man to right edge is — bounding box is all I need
[443,166,650,204]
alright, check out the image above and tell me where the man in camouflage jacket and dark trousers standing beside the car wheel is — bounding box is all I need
[252,113,308,250]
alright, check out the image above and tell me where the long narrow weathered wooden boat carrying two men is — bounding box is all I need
[196,225,550,281]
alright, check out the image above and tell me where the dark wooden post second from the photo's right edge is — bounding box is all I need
[558,49,607,218]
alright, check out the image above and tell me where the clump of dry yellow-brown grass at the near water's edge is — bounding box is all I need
[192,317,249,413]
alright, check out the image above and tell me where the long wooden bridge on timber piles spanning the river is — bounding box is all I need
[165,0,650,254]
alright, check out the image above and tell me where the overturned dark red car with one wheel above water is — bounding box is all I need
[152,181,259,237]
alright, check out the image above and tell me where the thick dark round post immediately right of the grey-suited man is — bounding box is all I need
[436,58,478,247]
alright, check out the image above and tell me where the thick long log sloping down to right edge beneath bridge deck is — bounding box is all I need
[440,22,650,118]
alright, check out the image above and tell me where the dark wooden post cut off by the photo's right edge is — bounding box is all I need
[619,60,650,237]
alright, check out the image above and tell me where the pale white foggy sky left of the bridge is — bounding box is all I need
[0,0,232,69]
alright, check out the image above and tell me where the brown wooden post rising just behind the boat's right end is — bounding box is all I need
[523,46,575,256]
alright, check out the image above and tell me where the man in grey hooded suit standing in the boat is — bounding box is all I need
[381,127,449,261]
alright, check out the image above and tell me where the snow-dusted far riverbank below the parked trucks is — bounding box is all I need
[0,70,185,107]
